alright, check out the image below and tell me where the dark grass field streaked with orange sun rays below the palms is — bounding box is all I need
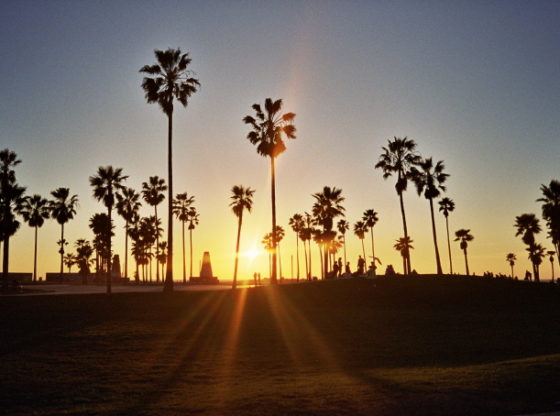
[0,277,560,416]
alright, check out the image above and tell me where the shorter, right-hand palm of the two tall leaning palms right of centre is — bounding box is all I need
[410,157,450,275]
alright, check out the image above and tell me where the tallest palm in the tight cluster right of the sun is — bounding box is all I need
[312,186,345,278]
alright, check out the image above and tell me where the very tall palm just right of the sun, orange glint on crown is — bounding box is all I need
[243,98,296,284]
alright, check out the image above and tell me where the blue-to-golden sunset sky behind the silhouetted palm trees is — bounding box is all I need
[0,1,560,280]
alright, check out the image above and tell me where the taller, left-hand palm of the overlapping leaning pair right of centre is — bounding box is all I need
[375,137,420,274]
